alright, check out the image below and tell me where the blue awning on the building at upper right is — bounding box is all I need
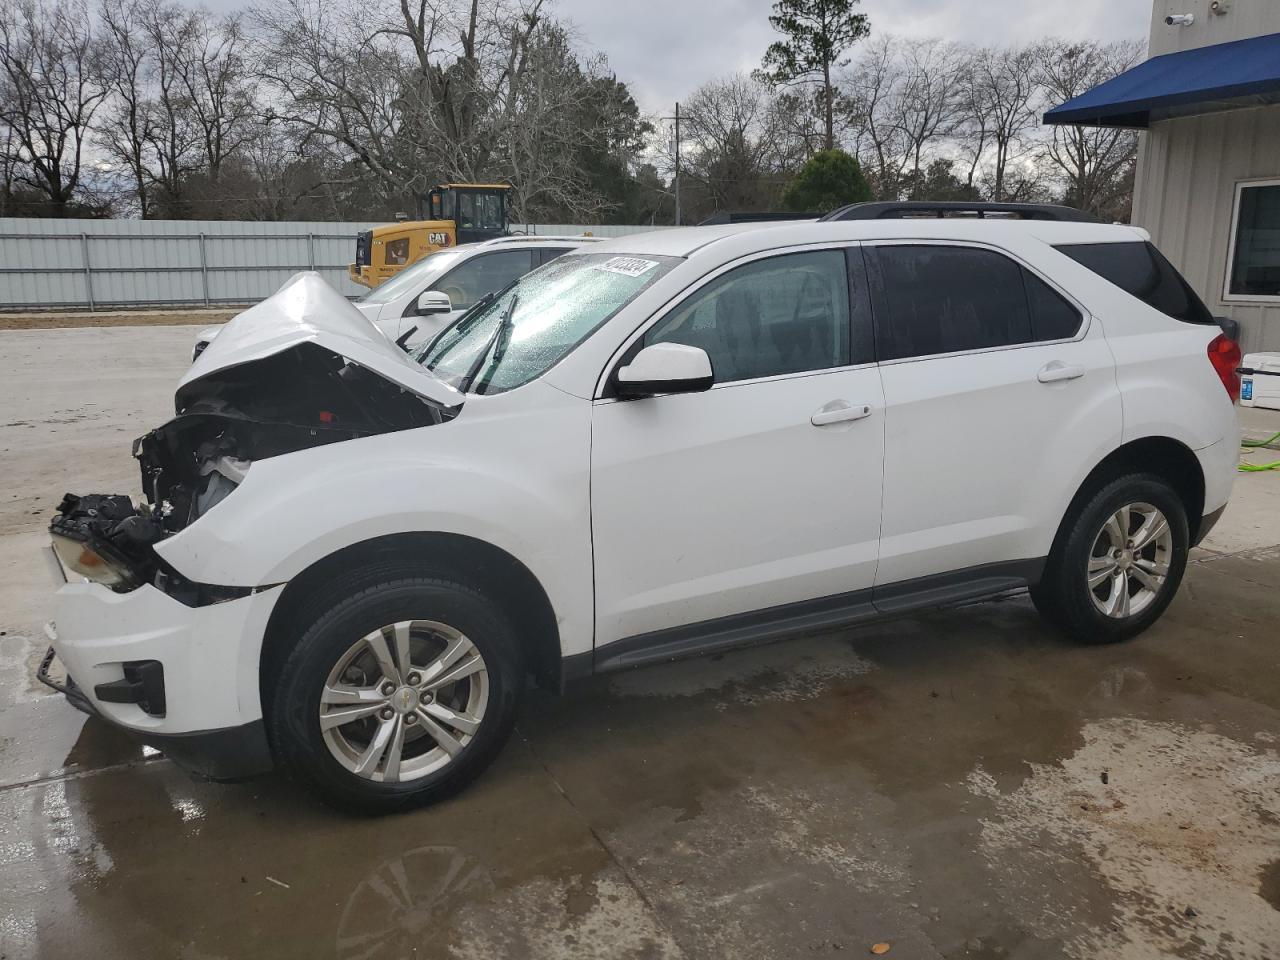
[1044,33,1280,127]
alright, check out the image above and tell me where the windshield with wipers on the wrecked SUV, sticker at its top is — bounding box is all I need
[412,253,677,393]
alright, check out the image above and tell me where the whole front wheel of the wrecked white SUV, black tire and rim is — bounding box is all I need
[268,576,524,814]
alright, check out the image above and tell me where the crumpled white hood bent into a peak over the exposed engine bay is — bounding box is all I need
[178,273,463,407]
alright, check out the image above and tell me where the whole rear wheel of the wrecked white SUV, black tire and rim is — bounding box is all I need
[1030,474,1189,644]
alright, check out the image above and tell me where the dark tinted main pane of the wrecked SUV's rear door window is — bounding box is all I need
[868,244,1032,360]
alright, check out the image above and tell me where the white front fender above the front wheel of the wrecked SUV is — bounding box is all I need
[155,381,593,655]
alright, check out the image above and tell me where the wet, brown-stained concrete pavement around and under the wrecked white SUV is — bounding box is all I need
[0,328,1280,960]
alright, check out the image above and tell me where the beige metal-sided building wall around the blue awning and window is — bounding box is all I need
[1133,0,1280,352]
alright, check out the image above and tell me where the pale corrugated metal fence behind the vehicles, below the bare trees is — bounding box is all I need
[0,218,652,310]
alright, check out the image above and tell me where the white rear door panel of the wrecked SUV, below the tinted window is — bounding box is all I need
[877,325,1121,584]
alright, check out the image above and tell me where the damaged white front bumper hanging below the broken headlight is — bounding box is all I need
[41,555,283,778]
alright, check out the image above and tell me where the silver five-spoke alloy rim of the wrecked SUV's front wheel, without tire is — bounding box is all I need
[319,620,489,783]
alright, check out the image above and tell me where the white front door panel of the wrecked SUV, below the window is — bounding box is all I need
[591,365,884,646]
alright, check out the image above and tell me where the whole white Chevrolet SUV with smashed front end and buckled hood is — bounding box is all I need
[41,209,1239,810]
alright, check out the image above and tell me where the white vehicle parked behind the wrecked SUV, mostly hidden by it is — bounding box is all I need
[191,237,595,362]
